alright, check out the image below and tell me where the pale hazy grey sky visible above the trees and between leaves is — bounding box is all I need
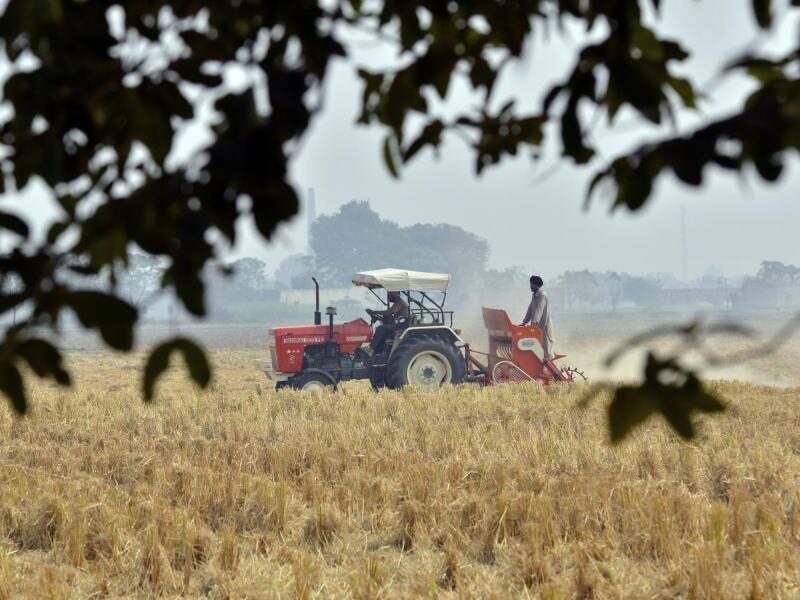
[3,0,800,284]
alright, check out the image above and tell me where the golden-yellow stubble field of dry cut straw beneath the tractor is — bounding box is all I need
[0,316,800,599]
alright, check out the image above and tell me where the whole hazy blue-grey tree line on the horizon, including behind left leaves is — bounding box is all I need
[15,200,784,321]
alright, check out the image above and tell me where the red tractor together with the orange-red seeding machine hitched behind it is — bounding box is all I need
[258,269,585,391]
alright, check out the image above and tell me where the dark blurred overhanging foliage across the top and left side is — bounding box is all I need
[0,0,800,440]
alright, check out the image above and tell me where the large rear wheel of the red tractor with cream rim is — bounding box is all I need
[386,335,467,389]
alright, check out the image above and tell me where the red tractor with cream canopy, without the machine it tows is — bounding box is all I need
[263,269,467,391]
